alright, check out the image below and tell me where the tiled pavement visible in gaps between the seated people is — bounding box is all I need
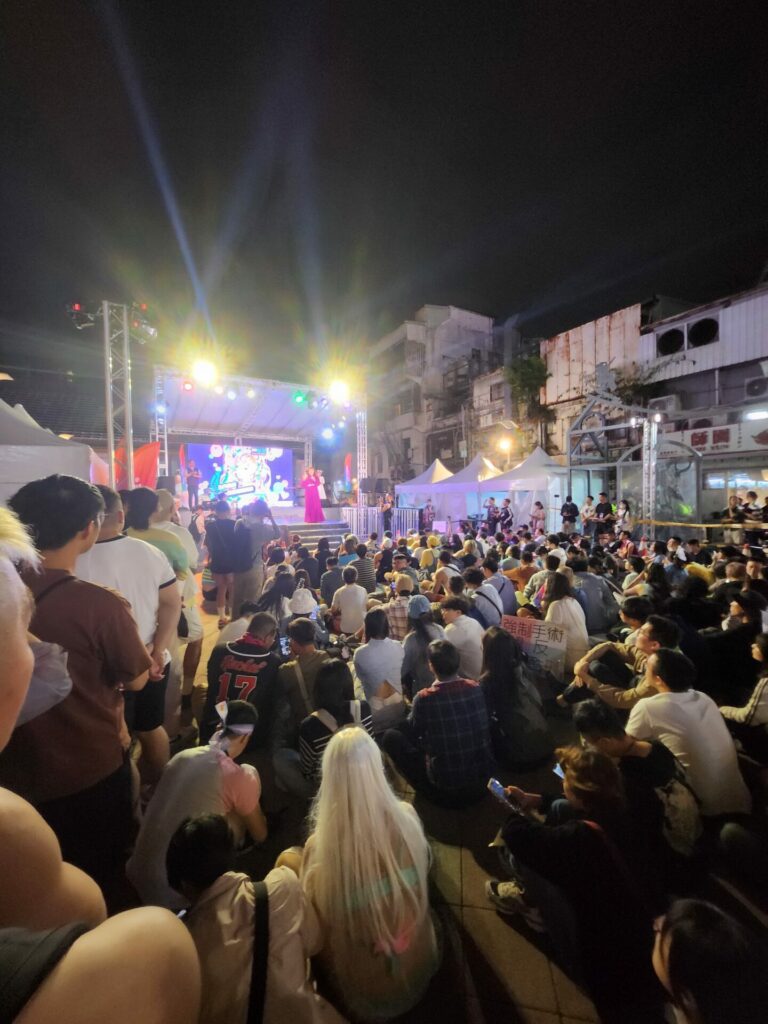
[191,598,598,1024]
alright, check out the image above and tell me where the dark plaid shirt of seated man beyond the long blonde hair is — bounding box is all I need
[410,679,494,790]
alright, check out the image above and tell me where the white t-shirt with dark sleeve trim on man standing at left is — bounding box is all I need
[75,536,176,643]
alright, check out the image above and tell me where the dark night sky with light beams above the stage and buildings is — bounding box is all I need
[0,0,768,379]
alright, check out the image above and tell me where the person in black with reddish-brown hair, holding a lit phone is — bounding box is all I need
[485,748,660,1024]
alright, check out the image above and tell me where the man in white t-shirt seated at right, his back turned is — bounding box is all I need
[627,647,752,817]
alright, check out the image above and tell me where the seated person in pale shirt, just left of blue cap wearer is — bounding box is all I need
[352,598,413,732]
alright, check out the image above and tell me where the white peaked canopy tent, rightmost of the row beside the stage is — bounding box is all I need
[480,447,568,529]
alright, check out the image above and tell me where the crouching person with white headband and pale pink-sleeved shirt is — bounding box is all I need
[126,700,267,910]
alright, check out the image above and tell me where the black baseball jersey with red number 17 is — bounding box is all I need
[200,637,288,751]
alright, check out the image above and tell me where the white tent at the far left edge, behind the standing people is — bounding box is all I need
[0,400,90,502]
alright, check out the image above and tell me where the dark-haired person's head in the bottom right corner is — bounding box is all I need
[653,899,768,1024]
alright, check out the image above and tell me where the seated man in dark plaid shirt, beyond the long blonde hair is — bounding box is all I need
[381,638,493,807]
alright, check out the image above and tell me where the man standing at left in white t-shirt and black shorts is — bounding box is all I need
[75,484,181,782]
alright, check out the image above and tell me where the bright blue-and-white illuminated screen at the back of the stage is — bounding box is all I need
[185,444,294,508]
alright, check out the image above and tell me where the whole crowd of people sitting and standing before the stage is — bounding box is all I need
[0,476,768,1024]
